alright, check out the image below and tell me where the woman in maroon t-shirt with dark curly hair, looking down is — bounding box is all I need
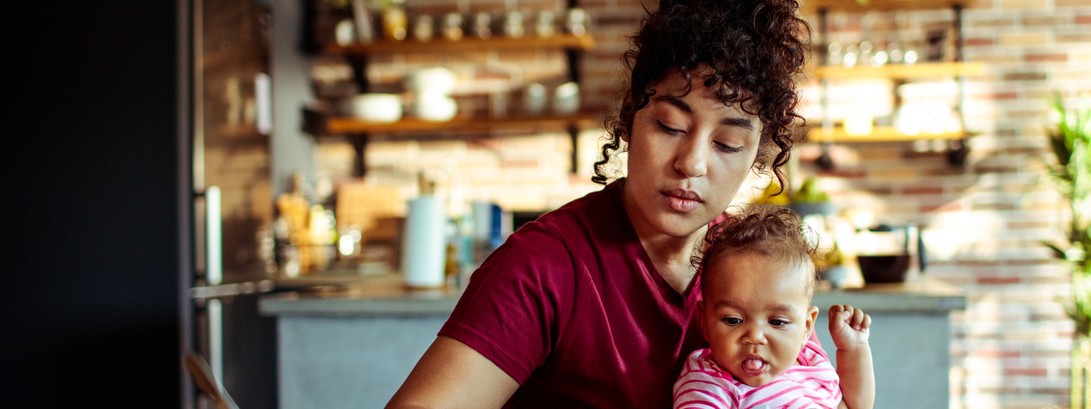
[387,0,807,408]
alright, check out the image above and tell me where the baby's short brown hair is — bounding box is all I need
[691,204,818,297]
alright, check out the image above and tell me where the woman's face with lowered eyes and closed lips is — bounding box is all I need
[625,70,762,242]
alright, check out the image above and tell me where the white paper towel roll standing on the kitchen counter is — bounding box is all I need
[401,196,446,289]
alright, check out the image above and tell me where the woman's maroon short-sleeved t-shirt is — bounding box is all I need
[440,180,705,408]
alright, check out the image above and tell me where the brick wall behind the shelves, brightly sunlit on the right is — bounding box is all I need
[319,0,1091,408]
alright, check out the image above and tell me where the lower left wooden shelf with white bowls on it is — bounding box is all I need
[311,112,601,135]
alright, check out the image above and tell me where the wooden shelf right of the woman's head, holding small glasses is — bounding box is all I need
[814,62,985,80]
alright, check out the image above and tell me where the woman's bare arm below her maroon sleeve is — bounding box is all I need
[386,336,519,409]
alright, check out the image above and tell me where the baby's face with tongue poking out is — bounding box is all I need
[702,253,818,386]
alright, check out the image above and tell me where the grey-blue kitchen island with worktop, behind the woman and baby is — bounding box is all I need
[260,275,966,408]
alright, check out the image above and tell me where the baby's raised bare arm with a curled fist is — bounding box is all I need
[829,304,875,409]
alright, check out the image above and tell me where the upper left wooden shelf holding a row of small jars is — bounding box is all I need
[325,35,595,56]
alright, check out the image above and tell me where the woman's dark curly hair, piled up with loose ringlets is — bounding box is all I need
[591,0,811,191]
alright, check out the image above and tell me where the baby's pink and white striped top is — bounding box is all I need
[674,336,841,409]
